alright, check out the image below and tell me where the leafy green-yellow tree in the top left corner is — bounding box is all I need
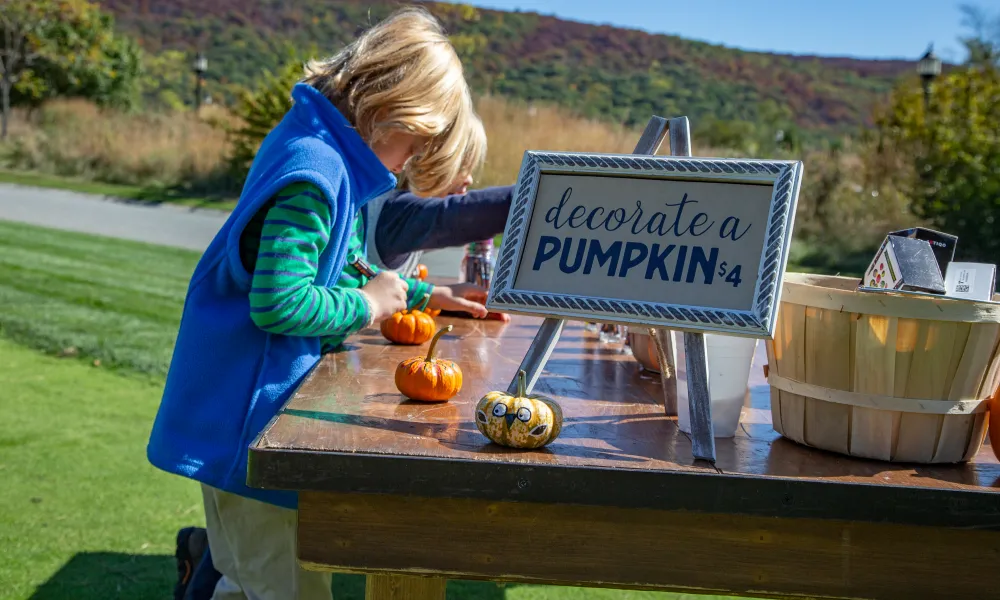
[0,0,141,137]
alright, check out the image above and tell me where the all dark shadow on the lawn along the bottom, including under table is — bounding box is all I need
[30,552,510,600]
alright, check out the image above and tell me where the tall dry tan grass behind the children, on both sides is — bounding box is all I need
[0,96,704,192]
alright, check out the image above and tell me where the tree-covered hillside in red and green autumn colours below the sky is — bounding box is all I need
[100,0,913,137]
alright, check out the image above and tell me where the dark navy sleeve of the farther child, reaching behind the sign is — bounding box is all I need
[375,185,514,264]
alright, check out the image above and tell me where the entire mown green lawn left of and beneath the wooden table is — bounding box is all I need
[0,221,748,600]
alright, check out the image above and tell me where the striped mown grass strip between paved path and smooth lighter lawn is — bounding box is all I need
[0,221,199,376]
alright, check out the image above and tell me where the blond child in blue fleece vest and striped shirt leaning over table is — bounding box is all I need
[147,9,486,599]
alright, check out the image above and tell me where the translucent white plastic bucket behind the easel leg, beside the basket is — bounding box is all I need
[671,331,757,438]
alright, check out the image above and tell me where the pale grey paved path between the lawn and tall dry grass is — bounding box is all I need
[0,183,461,276]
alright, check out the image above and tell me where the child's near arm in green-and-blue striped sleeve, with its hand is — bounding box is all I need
[250,184,405,336]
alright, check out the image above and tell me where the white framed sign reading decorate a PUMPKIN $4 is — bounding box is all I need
[486,151,802,338]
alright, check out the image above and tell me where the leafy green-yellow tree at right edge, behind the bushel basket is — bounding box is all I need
[876,67,1000,263]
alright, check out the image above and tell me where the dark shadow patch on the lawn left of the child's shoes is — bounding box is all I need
[31,552,177,600]
